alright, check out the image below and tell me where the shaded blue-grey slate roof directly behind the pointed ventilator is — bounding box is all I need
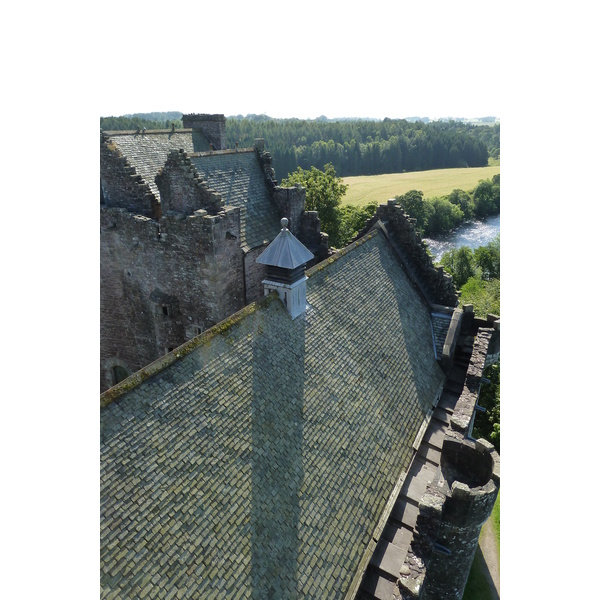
[190,149,280,250]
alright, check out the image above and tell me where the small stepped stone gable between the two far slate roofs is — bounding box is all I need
[155,150,225,215]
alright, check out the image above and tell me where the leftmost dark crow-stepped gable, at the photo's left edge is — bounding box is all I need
[100,133,160,219]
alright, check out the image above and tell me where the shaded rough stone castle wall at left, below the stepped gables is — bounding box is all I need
[100,207,244,390]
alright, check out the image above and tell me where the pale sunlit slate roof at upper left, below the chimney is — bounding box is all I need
[106,129,210,198]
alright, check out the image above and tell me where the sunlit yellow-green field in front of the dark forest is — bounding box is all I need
[342,161,500,206]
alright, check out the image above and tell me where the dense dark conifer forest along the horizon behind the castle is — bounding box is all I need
[100,112,500,180]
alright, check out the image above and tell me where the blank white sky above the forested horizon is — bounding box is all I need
[98,0,502,119]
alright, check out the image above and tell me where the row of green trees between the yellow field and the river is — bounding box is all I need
[395,174,500,236]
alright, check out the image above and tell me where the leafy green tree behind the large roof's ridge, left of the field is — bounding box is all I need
[281,164,348,248]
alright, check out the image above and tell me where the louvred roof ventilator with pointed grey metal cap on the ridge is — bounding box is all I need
[256,217,314,319]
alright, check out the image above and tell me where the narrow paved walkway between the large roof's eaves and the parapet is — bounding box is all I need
[356,338,473,600]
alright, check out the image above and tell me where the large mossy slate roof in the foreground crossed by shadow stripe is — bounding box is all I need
[101,233,443,599]
